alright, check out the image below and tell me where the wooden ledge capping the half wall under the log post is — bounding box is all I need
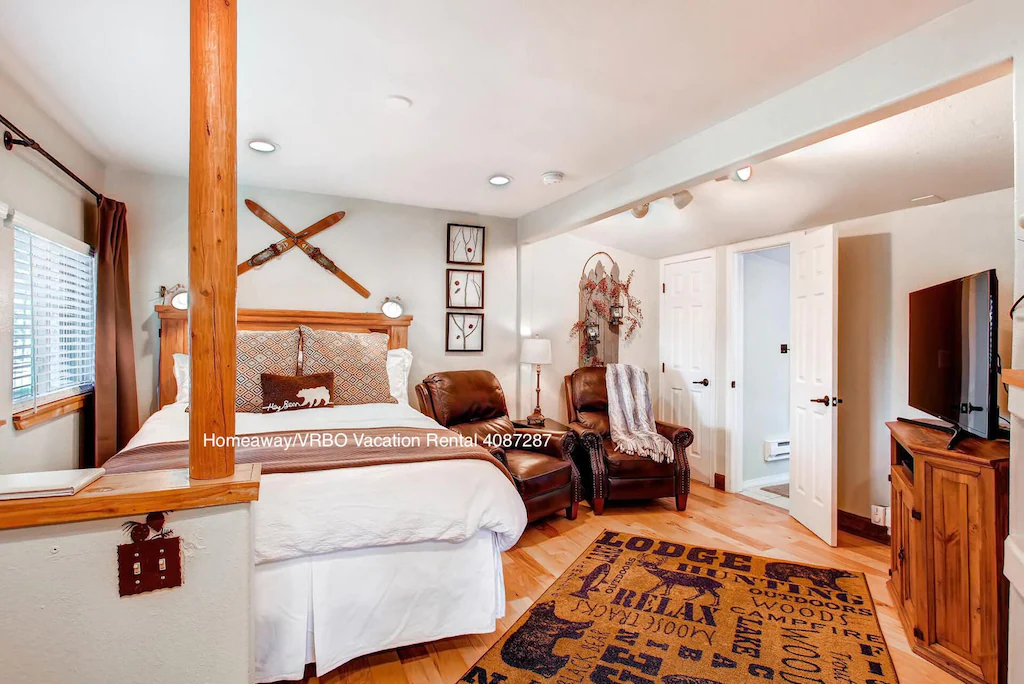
[0,463,262,529]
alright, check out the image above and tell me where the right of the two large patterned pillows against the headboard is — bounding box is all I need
[302,326,398,404]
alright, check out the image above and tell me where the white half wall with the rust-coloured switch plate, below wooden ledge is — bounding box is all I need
[0,504,253,684]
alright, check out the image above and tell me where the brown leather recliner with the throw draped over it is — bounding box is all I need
[565,368,693,515]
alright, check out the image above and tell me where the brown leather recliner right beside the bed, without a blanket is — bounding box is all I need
[416,371,583,522]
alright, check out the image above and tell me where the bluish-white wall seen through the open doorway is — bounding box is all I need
[745,247,791,481]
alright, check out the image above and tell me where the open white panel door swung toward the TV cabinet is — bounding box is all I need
[790,225,838,546]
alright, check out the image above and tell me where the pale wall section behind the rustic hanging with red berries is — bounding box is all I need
[519,234,662,422]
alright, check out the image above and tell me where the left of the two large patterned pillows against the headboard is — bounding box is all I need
[234,328,299,414]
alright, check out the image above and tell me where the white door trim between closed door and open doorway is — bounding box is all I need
[724,230,804,493]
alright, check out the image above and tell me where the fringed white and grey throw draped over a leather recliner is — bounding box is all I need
[606,364,675,463]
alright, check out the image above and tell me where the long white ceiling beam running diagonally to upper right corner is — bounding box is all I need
[518,0,1024,243]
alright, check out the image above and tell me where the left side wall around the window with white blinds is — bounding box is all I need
[0,63,103,473]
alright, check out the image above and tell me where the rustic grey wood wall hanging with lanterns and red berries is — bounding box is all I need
[569,252,643,368]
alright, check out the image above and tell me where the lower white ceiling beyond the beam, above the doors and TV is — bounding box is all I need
[573,76,1014,257]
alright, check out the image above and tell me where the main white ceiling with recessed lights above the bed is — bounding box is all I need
[0,0,966,217]
